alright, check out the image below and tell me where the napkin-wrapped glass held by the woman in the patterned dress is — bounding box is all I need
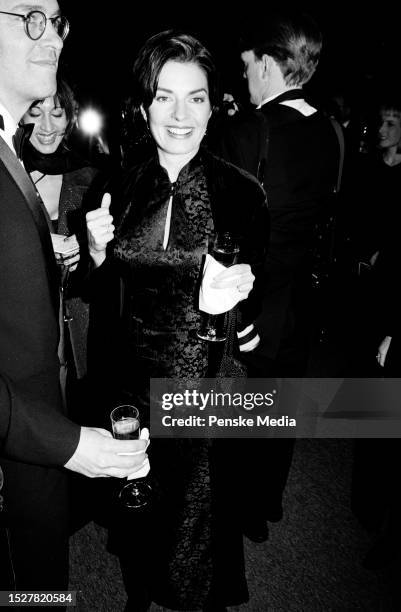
[197,232,239,342]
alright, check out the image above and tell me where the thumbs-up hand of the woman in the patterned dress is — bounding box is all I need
[86,193,114,267]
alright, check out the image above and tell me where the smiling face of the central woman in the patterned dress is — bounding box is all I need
[142,61,211,161]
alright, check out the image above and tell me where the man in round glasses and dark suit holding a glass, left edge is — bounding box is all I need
[0,0,145,590]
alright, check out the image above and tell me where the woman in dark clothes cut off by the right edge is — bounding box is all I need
[353,99,401,569]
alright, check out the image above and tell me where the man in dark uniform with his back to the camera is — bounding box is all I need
[219,10,339,540]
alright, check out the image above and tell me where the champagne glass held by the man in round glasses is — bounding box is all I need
[110,404,152,508]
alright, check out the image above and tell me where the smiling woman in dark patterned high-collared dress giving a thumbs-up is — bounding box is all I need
[87,31,268,612]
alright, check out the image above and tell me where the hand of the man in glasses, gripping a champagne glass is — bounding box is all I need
[64,427,149,478]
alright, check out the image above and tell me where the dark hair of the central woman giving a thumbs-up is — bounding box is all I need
[132,30,219,110]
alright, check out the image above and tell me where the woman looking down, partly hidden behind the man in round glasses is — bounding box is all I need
[22,79,97,403]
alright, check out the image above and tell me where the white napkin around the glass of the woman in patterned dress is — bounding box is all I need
[199,254,243,314]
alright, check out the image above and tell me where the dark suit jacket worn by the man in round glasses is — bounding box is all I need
[0,137,79,464]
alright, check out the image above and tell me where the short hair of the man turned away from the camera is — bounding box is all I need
[241,14,322,86]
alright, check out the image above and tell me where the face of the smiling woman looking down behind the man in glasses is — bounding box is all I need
[23,96,67,153]
